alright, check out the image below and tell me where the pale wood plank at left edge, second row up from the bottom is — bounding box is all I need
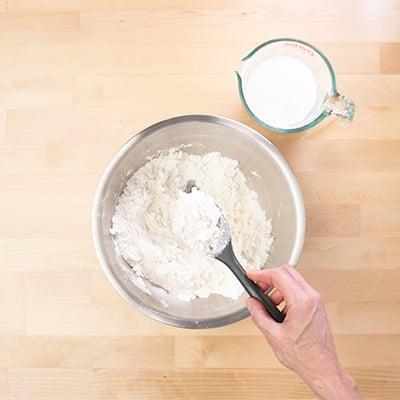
[0,336,175,369]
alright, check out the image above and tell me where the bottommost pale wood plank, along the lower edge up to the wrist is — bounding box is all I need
[8,367,312,400]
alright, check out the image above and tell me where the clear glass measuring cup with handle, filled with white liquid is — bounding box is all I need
[236,38,355,133]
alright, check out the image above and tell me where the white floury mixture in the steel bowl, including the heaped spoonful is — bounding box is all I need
[111,150,273,300]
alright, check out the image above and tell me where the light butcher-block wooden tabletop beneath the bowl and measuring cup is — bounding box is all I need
[0,0,400,400]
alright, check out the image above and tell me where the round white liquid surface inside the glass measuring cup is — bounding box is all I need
[244,56,317,128]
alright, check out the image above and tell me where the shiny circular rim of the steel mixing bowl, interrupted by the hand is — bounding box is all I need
[92,114,305,329]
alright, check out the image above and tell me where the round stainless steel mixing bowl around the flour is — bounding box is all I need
[92,115,305,328]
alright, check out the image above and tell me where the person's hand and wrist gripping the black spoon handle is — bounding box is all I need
[246,265,361,399]
